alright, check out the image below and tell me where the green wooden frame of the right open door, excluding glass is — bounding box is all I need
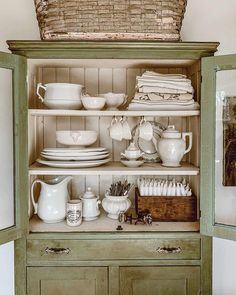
[200,55,236,240]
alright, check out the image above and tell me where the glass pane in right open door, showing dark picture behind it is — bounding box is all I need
[215,70,236,226]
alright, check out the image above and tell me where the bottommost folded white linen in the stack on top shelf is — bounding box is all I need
[128,102,200,111]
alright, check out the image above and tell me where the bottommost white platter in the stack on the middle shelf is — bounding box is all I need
[36,158,111,168]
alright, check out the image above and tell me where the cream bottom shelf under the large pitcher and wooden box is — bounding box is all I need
[29,212,199,233]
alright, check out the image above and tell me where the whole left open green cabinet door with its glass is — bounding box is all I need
[0,53,27,244]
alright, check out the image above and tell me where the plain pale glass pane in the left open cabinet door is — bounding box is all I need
[0,69,15,230]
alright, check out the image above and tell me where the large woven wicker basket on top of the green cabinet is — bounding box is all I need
[34,0,187,41]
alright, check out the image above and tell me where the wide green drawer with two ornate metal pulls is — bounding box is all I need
[27,238,201,261]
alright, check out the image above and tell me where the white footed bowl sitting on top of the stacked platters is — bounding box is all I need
[56,130,98,146]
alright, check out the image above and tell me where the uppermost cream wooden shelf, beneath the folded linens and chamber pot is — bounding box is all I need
[29,109,200,117]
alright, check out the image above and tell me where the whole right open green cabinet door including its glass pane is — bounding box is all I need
[201,55,236,239]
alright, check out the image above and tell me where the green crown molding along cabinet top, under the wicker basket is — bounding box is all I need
[7,41,219,60]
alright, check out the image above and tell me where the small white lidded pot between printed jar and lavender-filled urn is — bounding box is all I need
[81,187,101,221]
